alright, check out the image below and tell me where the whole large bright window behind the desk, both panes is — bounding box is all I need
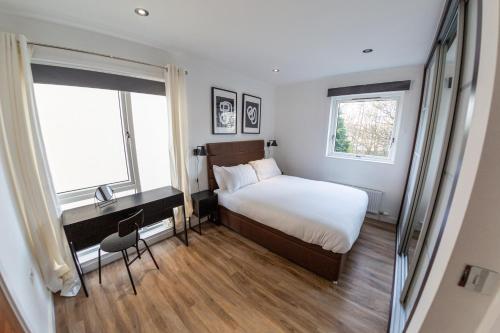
[35,83,170,205]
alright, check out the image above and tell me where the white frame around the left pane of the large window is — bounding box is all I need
[40,84,140,205]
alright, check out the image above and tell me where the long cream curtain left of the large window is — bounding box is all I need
[0,32,80,296]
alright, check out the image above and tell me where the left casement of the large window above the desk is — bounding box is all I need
[35,84,137,202]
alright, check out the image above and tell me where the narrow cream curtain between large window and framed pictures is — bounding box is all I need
[164,65,193,224]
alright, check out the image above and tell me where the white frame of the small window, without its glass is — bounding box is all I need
[326,91,405,164]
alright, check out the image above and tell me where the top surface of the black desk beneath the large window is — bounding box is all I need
[62,186,182,226]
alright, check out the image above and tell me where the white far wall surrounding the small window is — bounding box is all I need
[275,66,423,222]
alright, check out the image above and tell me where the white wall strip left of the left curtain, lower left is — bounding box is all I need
[0,152,54,332]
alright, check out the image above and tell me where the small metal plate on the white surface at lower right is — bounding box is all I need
[458,265,499,295]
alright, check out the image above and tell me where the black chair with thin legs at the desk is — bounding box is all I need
[98,209,160,295]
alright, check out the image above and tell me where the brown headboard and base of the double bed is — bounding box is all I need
[207,140,347,282]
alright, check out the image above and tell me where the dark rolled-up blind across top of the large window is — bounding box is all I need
[31,64,165,96]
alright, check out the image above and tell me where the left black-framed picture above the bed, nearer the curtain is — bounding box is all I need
[212,87,238,134]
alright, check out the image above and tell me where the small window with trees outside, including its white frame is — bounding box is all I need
[327,92,403,163]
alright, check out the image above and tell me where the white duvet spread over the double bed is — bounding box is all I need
[217,176,368,253]
